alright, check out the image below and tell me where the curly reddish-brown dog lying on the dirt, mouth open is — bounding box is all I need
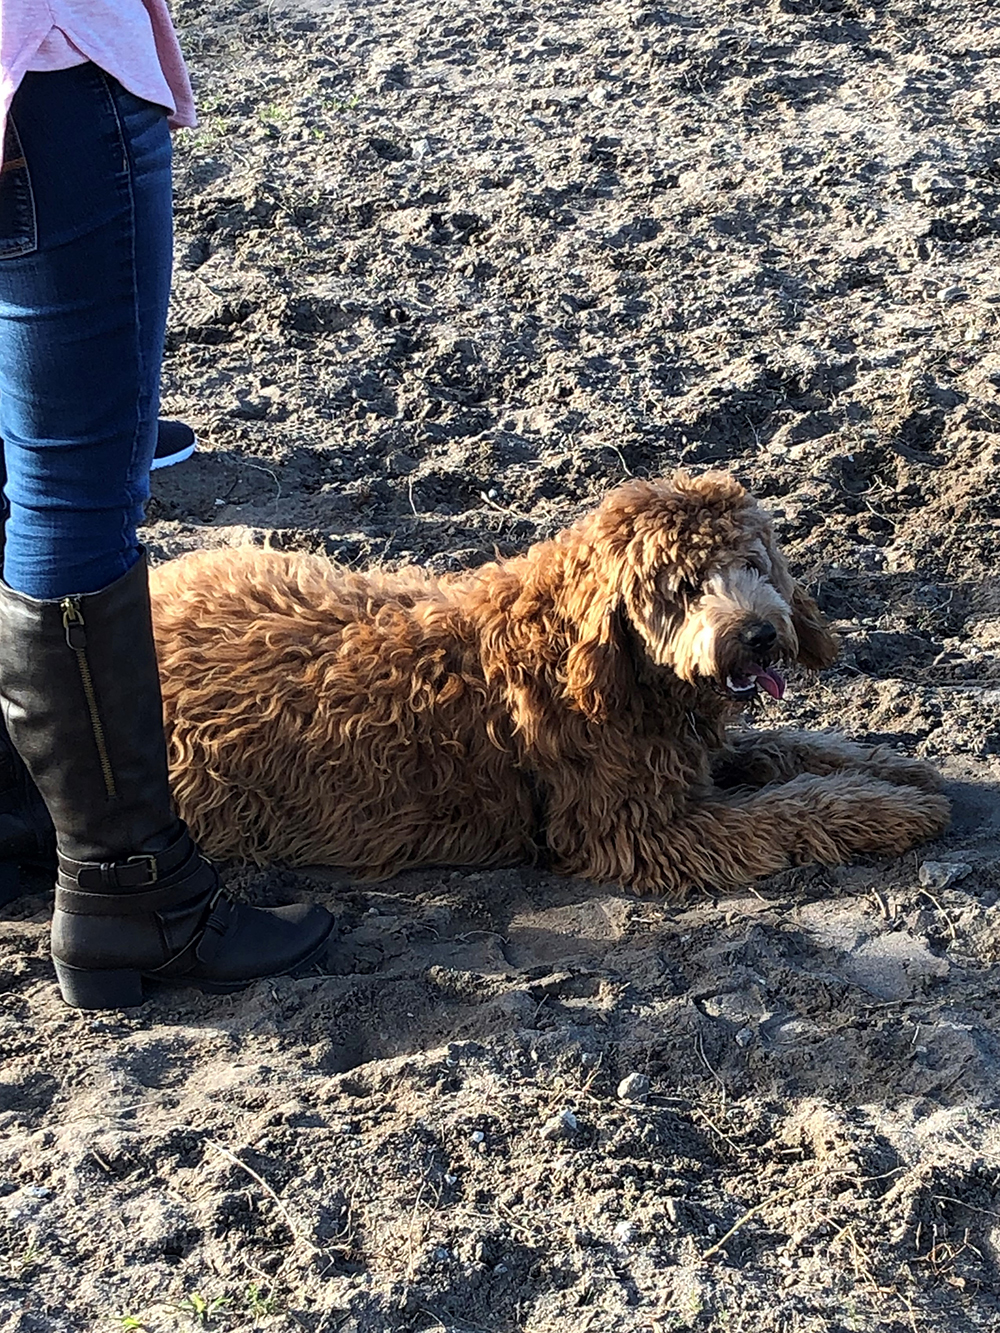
[153,473,948,896]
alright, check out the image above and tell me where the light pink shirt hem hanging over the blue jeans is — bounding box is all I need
[0,0,197,144]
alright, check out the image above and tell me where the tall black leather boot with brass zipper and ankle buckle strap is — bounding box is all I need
[0,560,333,1009]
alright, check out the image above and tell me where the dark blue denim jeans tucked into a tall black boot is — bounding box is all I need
[0,64,172,599]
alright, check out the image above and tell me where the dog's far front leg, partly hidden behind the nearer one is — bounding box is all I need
[712,730,941,792]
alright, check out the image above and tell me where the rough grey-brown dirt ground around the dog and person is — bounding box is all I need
[0,0,1000,1333]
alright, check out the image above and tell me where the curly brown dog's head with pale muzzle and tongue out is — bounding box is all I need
[567,472,837,717]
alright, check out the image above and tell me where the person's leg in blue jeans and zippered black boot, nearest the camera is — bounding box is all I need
[0,65,331,1008]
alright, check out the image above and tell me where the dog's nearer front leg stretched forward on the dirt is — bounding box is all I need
[551,773,949,897]
